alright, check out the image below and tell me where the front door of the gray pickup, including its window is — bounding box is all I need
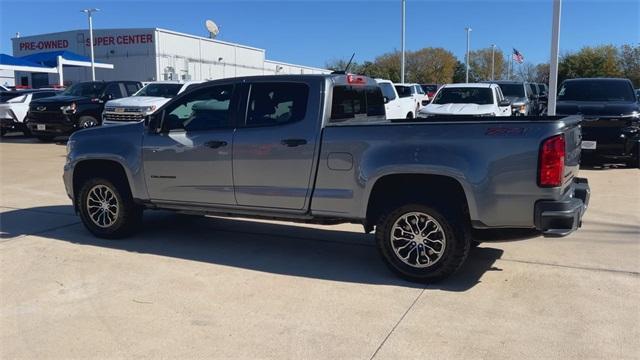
[143,84,236,205]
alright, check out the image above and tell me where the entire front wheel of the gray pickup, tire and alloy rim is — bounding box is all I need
[77,178,142,239]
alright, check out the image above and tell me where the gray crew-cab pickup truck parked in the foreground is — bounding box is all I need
[64,74,589,282]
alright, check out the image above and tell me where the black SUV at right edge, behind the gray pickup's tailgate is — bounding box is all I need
[556,78,640,167]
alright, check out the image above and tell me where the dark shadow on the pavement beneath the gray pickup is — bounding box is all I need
[0,206,502,291]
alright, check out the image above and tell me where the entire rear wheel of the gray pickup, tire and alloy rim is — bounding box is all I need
[376,204,471,283]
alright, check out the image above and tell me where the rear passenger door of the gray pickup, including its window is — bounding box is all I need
[232,78,322,212]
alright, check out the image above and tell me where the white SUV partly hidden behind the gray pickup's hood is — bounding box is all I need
[102,81,202,125]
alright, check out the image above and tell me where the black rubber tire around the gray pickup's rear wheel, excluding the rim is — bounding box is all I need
[376,204,471,282]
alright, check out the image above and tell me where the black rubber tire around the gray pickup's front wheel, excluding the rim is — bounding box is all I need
[77,178,141,239]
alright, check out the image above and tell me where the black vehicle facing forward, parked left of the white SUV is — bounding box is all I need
[26,81,142,141]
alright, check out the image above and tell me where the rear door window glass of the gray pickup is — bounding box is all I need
[246,82,309,126]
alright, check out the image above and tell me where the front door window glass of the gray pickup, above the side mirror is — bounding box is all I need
[164,85,233,132]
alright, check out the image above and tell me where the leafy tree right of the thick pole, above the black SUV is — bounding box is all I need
[558,45,623,81]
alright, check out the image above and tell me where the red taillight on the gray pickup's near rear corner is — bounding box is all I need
[538,135,566,187]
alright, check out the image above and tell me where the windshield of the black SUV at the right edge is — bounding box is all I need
[558,80,636,101]
